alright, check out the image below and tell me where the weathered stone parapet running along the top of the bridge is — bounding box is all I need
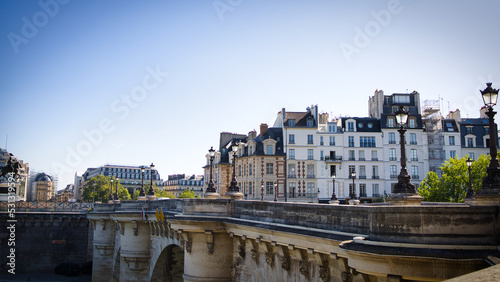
[92,199,500,246]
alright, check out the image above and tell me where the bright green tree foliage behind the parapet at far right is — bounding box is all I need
[418,155,490,203]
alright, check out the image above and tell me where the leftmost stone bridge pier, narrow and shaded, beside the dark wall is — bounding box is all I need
[90,215,115,282]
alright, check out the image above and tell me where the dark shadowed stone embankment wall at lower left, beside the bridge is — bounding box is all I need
[0,213,93,273]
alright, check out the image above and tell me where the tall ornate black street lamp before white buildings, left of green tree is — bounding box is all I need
[394,106,416,195]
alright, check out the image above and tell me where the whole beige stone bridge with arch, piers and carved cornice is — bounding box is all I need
[87,199,500,282]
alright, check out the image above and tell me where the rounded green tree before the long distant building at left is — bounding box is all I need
[82,175,130,203]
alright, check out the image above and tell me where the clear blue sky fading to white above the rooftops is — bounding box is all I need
[0,0,500,189]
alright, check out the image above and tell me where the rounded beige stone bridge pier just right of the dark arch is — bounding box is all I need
[183,230,233,282]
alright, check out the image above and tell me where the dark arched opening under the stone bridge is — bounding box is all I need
[151,244,184,282]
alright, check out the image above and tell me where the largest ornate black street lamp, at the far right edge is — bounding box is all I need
[476,82,500,196]
